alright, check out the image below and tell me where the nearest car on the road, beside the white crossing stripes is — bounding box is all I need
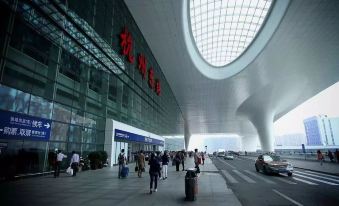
[255,154,293,176]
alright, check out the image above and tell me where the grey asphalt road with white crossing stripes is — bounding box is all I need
[212,157,339,206]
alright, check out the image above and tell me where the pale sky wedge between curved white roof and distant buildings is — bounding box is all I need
[274,82,339,136]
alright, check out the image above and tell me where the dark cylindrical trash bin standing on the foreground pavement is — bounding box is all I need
[185,168,198,201]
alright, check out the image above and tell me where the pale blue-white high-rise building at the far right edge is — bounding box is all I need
[304,115,339,146]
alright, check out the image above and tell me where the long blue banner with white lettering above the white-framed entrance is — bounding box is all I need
[114,129,164,146]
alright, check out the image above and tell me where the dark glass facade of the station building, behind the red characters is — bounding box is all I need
[0,0,183,175]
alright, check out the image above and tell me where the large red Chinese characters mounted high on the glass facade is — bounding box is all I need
[120,27,161,96]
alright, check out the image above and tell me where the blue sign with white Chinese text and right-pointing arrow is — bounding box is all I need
[0,110,51,141]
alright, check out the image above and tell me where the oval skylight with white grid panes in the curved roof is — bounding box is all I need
[189,0,272,67]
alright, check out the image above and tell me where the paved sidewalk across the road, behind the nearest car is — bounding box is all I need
[241,156,339,176]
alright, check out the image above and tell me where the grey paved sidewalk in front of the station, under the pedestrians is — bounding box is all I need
[0,158,241,206]
